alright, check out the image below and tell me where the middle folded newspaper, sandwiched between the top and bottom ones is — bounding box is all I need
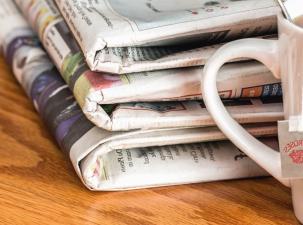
[16,0,282,131]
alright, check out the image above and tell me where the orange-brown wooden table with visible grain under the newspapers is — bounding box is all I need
[0,58,298,225]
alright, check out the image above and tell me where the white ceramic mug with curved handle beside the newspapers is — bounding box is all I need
[201,15,303,222]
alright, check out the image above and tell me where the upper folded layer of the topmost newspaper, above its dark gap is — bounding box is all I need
[56,0,280,46]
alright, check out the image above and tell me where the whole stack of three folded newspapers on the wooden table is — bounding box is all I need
[0,0,283,190]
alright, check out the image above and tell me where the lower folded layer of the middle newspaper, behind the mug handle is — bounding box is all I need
[105,98,284,130]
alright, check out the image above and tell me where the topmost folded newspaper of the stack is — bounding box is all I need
[56,0,280,73]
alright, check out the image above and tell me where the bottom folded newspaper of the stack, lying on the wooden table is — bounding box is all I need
[0,0,277,190]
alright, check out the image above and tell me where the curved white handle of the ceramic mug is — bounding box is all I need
[201,38,290,187]
